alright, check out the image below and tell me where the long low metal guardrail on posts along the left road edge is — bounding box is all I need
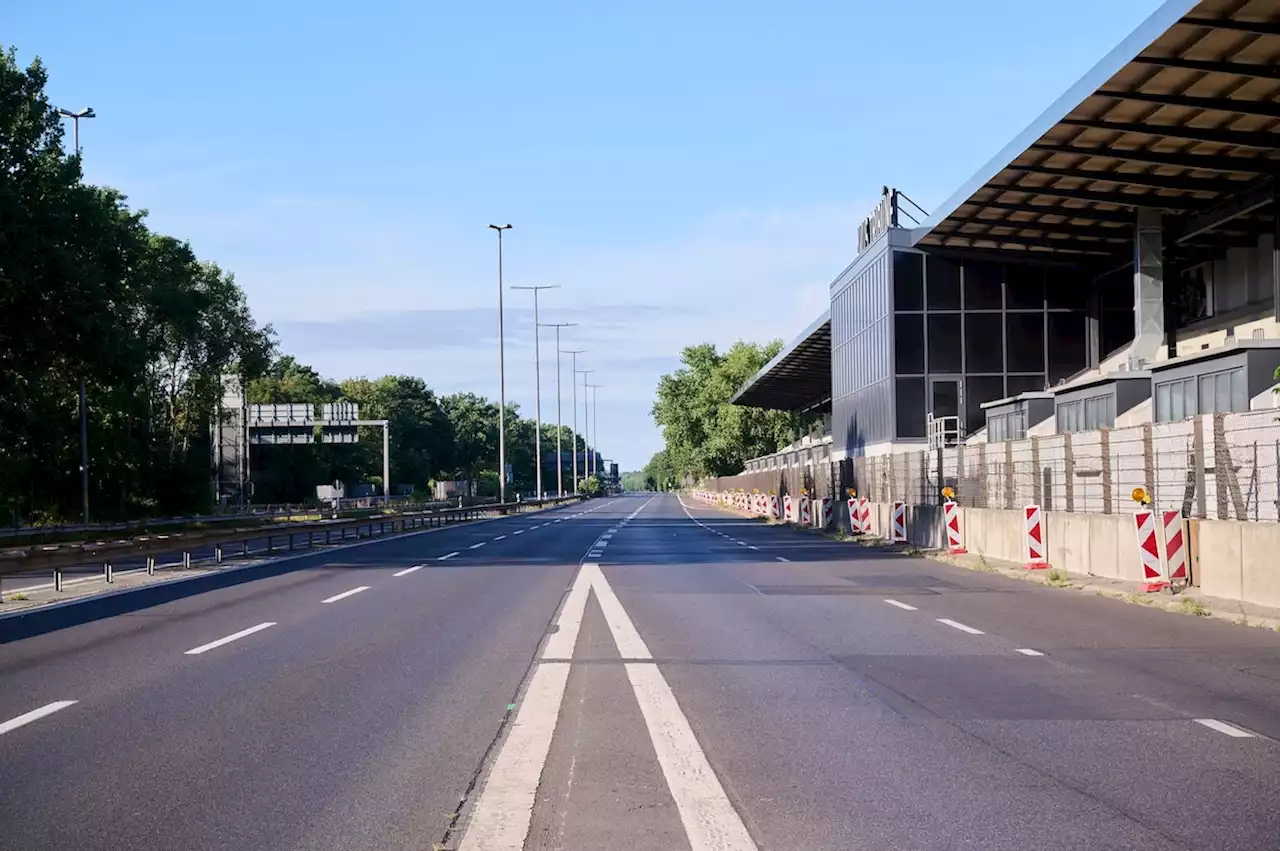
[0,497,579,591]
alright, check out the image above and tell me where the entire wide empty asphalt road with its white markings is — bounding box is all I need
[0,497,1280,851]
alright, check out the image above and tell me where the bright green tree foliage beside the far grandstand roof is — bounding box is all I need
[644,340,814,488]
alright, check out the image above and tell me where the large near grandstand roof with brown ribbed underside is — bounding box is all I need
[913,0,1280,258]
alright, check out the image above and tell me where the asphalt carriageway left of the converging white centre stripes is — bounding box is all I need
[0,500,611,850]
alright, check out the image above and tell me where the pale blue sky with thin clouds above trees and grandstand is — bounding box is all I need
[10,0,1160,470]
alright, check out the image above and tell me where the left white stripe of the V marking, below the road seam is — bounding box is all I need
[458,662,568,851]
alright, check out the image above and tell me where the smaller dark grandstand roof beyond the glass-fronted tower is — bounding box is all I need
[730,311,831,411]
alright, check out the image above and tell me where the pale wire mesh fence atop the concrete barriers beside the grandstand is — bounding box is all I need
[704,411,1280,521]
